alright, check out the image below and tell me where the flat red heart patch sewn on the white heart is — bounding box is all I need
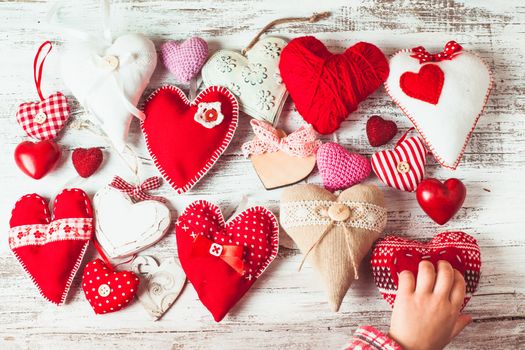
[399,64,445,105]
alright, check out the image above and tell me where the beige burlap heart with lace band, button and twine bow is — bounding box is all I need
[280,184,387,311]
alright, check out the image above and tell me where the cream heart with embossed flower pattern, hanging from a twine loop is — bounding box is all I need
[202,37,288,124]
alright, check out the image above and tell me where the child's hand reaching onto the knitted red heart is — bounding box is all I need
[389,260,472,350]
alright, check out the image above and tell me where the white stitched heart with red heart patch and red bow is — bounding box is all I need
[385,41,492,169]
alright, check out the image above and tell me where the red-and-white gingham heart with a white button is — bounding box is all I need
[16,92,69,140]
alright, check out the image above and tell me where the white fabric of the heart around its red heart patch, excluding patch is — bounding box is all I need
[385,50,492,169]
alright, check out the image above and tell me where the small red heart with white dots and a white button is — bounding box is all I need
[82,259,139,314]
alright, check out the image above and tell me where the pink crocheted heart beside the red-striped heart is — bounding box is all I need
[317,142,371,192]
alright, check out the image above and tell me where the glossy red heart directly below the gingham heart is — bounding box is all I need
[15,140,61,180]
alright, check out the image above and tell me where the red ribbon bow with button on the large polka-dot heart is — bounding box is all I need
[191,234,244,276]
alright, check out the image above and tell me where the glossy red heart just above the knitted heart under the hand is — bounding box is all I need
[416,178,467,225]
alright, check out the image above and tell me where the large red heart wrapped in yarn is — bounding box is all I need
[279,36,389,134]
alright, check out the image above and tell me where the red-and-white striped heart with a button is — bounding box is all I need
[372,136,427,192]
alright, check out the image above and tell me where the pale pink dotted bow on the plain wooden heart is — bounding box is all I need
[242,119,321,158]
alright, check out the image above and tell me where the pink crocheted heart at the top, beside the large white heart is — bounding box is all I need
[160,36,208,82]
